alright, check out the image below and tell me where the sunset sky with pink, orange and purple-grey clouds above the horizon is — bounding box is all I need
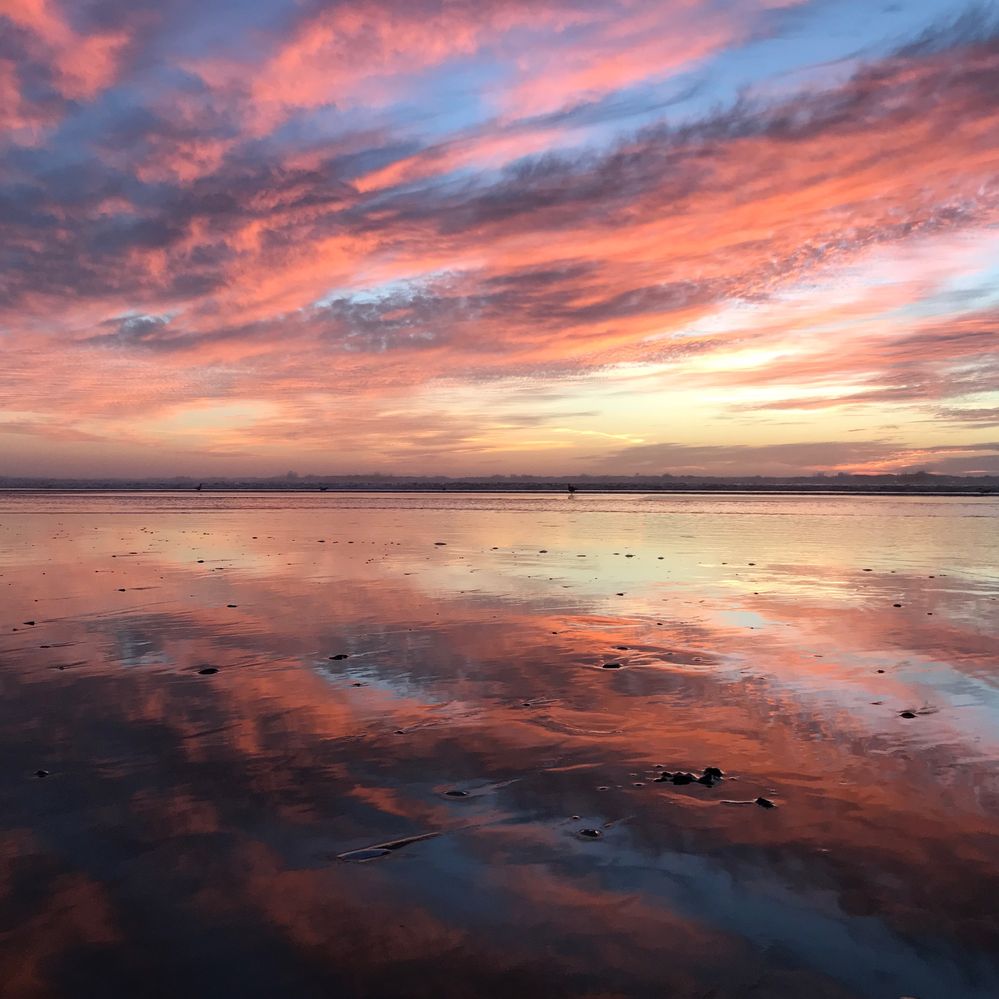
[0,0,999,476]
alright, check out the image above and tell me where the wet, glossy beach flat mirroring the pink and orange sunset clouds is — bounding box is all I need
[0,493,999,999]
